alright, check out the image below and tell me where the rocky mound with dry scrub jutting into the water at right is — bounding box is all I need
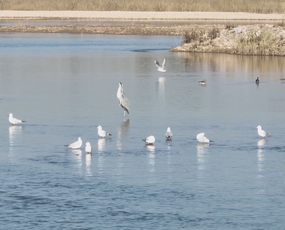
[171,24,285,56]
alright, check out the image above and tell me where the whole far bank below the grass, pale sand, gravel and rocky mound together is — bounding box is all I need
[0,11,285,56]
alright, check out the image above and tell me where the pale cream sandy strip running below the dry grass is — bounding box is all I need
[0,10,285,22]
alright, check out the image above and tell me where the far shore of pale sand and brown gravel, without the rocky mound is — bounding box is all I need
[0,10,285,36]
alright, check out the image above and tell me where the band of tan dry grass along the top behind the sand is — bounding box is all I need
[0,0,285,13]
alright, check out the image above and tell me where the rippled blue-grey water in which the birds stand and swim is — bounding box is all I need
[0,33,285,230]
